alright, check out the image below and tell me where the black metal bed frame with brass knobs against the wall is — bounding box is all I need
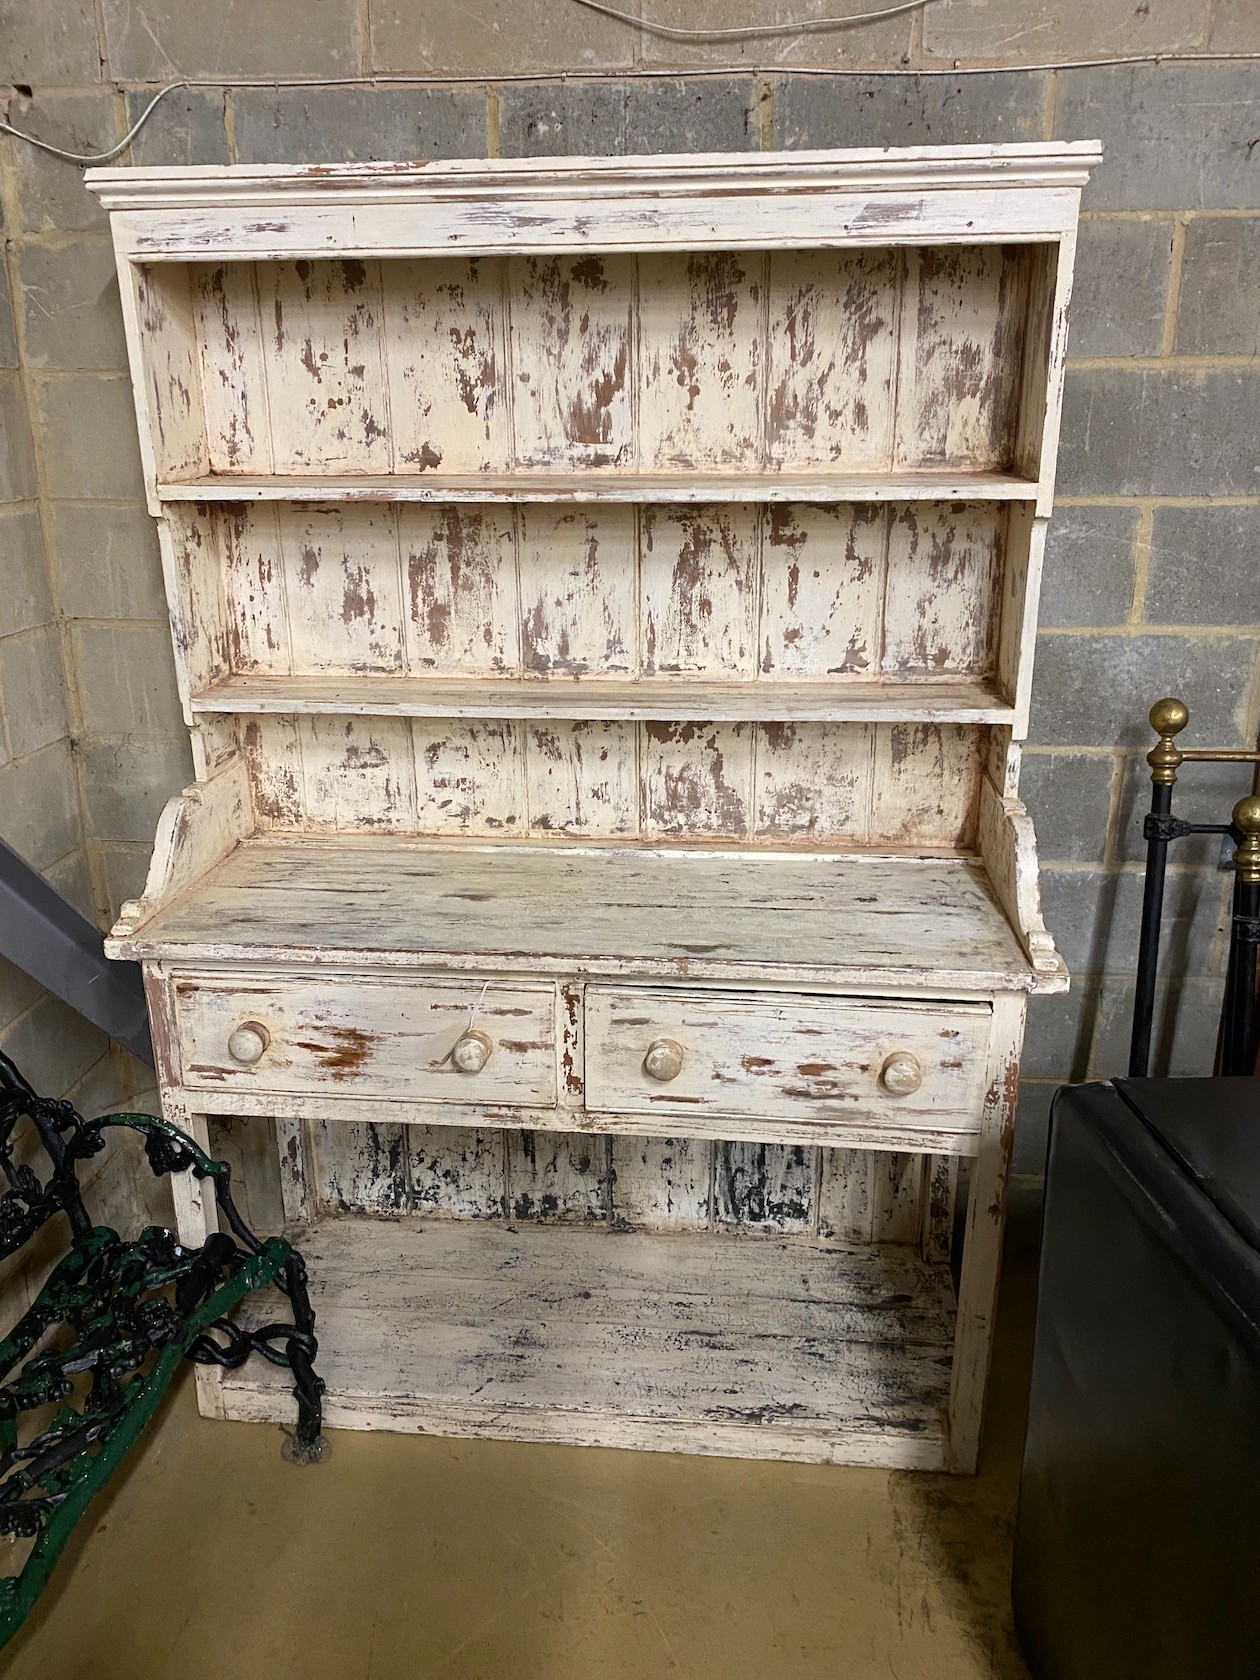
[1129,699,1260,1079]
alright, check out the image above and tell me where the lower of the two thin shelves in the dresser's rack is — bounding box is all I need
[192,675,1015,724]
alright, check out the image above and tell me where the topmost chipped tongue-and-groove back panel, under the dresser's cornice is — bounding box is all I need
[141,245,1034,477]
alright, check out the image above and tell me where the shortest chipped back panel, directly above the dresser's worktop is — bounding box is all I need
[240,714,986,847]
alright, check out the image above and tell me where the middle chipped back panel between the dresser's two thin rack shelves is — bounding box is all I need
[186,502,1018,685]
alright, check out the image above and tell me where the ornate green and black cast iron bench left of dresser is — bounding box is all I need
[0,1055,324,1645]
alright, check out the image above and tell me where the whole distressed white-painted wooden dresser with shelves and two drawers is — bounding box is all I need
[87,144,1099,1470]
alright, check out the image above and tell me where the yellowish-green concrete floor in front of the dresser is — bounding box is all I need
[0,1272,1033,1680]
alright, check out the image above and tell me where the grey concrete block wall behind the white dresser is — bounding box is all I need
[0,0,1260,1216]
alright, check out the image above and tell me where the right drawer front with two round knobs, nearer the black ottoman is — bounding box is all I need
[586,986,991,1132]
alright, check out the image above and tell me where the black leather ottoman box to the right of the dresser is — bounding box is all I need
[1015,1079,1260,1680]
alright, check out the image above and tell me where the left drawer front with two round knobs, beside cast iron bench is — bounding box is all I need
[173,974,556,1107]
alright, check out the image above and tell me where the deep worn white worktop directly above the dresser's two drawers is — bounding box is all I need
[111,835,1038,993]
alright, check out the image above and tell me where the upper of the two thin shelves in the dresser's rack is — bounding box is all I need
[158,469,1040,502]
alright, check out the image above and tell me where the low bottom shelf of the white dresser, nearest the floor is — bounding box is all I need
[215,1218,956,1470]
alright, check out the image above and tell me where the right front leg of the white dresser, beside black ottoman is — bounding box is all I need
[949,993,1026,1475]
